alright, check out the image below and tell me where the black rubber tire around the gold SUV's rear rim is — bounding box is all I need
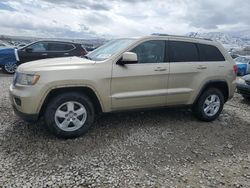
[193,88,225,122]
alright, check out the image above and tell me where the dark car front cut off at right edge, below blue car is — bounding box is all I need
[237,75,250,100]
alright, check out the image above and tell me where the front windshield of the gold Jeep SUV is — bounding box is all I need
[86,39,134,61]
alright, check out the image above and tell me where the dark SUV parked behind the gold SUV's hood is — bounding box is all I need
[17,41,87,65]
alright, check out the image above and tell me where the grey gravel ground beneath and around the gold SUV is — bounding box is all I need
[0,71,250,187]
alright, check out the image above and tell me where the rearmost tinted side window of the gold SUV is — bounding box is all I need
[198,44,225,61]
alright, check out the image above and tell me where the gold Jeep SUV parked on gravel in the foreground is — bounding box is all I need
[10,35,237,138]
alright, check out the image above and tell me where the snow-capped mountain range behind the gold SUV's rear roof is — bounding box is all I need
[187,32,250,49]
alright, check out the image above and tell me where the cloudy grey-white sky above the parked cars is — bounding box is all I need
[0,0,250,38]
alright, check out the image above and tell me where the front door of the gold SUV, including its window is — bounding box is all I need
[111,40,169,110]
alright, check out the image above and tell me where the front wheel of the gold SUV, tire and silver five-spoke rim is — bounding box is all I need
[45,92,94,138]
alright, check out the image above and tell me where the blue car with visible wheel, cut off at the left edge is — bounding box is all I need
[0,48,18,74]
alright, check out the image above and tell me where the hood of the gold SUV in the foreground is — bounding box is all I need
[17,57,95,72]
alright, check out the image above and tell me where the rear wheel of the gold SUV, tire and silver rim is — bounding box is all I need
[193,88,224,121]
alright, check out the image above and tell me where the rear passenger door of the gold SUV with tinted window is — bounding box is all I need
[167,40,205,105]
